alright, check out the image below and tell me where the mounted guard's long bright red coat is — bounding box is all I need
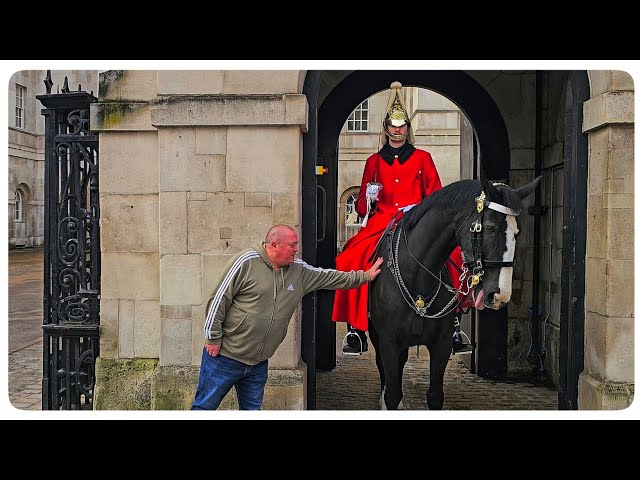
[331,149,462,331]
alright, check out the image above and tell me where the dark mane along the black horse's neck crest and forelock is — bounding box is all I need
[404,180,522,230]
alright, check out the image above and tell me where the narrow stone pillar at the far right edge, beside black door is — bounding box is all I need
[578,71,634,410]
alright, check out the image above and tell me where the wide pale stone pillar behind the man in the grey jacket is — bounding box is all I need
[92,71,308,409]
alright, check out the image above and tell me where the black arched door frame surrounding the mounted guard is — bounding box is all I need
[302,70,510,409]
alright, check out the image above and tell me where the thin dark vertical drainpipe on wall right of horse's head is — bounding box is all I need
[527,70,546,373]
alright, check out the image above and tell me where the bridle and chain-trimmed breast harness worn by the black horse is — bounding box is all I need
[384,189,518,318]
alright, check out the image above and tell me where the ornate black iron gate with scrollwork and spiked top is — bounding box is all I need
[36,71,100,410]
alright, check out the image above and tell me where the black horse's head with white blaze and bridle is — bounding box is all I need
[458,172,541,310]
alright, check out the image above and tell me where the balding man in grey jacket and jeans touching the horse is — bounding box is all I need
[191,225,382,410]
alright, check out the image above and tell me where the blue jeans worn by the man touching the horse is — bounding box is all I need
[191,348,269,410]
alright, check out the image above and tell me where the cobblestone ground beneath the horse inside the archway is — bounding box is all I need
[316,323,558,410]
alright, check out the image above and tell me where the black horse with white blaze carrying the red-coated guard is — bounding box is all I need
[369,174,540,410]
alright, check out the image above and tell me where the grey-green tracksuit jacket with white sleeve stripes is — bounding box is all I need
[204,244,370,365]
